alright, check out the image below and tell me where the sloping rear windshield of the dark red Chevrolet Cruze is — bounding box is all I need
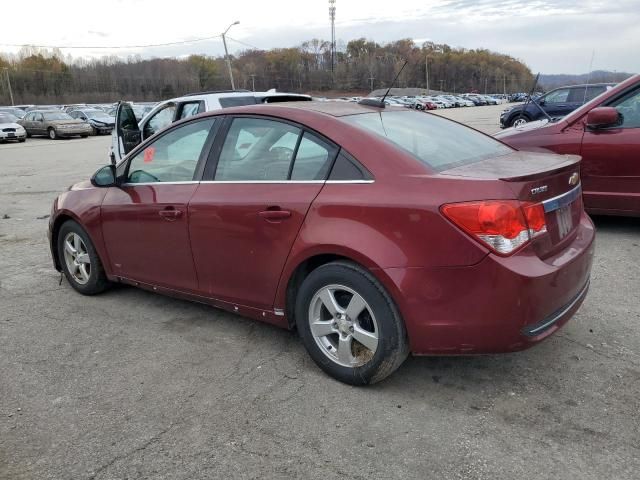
[342,111,513,172]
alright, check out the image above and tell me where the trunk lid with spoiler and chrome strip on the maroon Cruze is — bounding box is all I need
[440,151,583,258]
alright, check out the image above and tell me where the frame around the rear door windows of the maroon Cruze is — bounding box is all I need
[202,114,348,184]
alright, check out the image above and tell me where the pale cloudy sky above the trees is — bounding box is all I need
[0,0,640,74]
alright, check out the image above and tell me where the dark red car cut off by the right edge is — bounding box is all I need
[496,75,640,217]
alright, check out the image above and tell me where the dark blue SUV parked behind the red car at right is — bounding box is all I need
[500,83,615,128]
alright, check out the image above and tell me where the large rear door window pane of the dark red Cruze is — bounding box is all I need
[215,118,301,181]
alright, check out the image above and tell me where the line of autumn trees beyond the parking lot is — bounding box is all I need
[0,38,533,104]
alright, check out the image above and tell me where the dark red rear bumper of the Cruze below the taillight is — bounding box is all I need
[384,213,595,355]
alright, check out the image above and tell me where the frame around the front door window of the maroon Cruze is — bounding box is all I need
[121,117,222,187]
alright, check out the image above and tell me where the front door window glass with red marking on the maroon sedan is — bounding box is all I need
[127,119,215,183]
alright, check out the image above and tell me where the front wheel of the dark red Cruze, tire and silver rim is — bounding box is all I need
[56,220,109,295]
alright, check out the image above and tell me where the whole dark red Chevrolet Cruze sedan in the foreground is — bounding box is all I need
[49,102,594,384]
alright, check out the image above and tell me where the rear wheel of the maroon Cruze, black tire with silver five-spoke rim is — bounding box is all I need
[295,261,409,385]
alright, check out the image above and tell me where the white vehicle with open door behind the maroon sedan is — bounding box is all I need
[109,90,311,162]
